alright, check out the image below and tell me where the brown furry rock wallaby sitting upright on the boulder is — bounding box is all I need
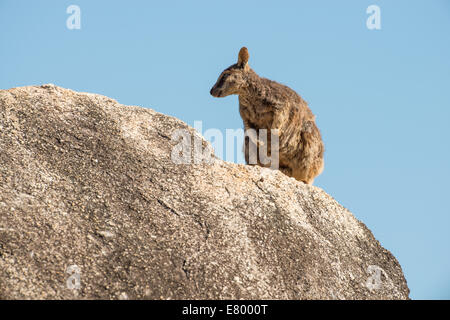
[210,47,324,184]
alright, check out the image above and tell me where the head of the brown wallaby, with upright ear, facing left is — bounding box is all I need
[210,47,250,98]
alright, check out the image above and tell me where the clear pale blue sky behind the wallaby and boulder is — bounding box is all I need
[0,0,450,299]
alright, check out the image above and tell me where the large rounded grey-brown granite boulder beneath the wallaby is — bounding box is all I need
[0,85,409,299]
